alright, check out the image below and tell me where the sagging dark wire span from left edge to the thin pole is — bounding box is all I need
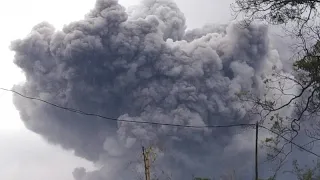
[0,88,255,128]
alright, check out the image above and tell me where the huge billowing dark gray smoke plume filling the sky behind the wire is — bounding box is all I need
[12,0,282,180]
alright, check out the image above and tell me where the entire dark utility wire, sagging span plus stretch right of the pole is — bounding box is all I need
[0,88,320,158]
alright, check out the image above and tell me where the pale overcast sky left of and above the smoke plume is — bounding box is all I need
[0,0,232,180]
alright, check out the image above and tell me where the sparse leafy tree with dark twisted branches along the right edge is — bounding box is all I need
[233,0,320,179]
